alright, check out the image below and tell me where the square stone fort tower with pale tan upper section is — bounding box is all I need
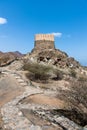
[34,34,55,50]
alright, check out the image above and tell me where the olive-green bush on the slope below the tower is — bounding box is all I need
[23,63,51,81]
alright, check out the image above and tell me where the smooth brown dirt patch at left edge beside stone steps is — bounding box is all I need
[0,75,24,107]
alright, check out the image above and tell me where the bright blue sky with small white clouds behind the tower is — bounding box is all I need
[0,0,87,65]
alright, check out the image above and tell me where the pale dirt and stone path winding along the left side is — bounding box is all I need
[0,71,42,130]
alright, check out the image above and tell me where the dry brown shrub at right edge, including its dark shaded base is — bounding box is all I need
[58,80,87,126]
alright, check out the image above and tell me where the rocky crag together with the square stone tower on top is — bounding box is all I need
[25,34,81,68]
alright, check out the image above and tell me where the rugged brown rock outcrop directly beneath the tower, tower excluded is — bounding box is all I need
[25,49,81,68]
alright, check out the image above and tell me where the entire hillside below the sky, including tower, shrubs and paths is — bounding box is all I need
[0,34,87,130]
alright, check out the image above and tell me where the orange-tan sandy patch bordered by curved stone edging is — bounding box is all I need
[21,94,67,109]
